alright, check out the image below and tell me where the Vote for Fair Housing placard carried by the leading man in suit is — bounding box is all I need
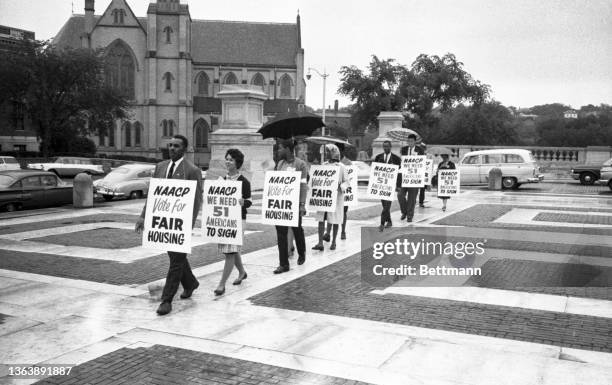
[142,178,197,253]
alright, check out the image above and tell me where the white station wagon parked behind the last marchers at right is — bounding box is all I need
[457,149,544,189]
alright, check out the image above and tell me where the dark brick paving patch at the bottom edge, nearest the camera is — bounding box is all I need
[37,345,367,385]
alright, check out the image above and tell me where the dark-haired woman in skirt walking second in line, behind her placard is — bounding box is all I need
[215,148,251,295]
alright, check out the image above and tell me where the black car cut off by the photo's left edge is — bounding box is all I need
[0,170,72,211]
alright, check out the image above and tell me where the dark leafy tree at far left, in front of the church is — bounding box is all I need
[0,43,129,156]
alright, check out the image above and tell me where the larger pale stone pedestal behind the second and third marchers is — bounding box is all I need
[206,85,274,190]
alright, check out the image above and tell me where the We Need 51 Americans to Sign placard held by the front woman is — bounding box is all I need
[202,179,243,245]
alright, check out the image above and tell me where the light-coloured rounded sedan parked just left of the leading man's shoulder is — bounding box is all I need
[94,164,155,201]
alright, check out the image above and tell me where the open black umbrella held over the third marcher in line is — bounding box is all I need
[257,112,325,139]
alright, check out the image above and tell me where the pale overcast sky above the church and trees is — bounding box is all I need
[0,0,612,108]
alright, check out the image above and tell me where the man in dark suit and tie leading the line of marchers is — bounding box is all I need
[136,135,202,315]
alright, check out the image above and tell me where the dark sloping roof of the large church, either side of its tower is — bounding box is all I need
[53,15,301,68]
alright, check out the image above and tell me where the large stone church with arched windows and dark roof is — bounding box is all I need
[53,0,305,166]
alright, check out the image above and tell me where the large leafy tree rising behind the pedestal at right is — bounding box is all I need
[338,53,489,127]
